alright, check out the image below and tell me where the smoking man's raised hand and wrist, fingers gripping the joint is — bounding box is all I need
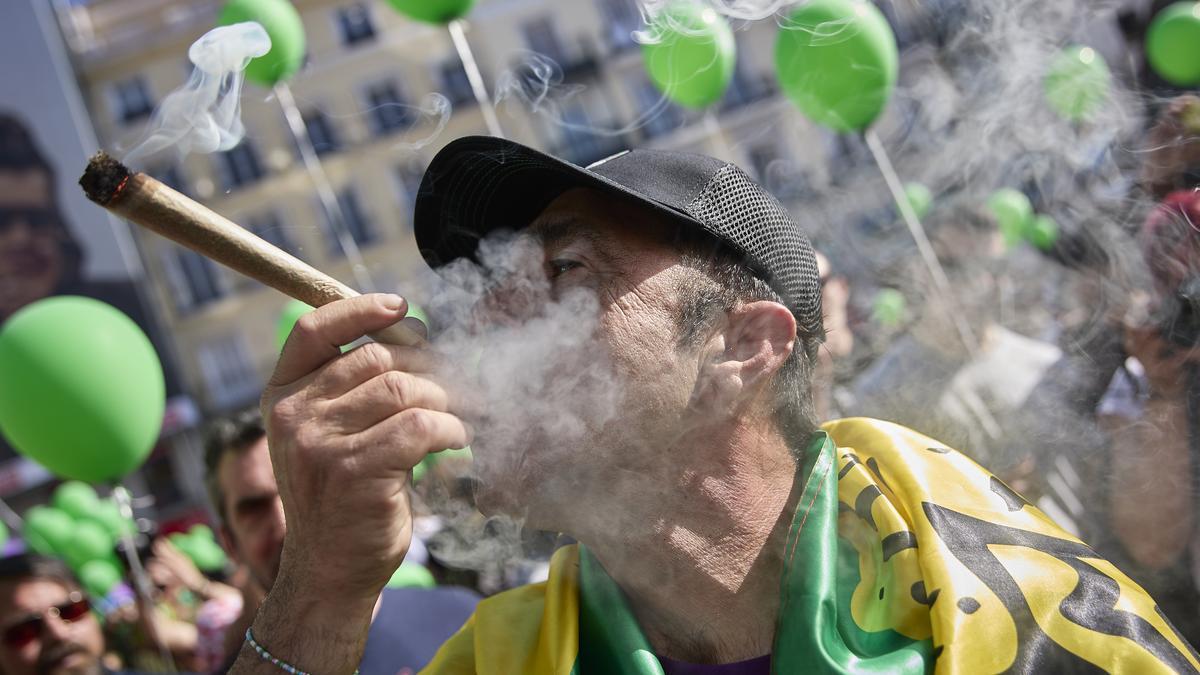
[243,294,470,673]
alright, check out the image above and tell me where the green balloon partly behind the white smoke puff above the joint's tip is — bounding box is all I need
[217,0,306,88]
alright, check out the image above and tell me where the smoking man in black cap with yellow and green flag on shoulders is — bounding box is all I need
[223,137,1200,675]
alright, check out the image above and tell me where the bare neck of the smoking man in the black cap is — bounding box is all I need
[584,425,799,663]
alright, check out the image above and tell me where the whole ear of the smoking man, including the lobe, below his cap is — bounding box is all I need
[692,300,796,414]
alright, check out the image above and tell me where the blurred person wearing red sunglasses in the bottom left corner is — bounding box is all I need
[0,555,104,675]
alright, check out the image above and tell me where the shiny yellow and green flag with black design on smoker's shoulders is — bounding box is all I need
[425,418,1200,675]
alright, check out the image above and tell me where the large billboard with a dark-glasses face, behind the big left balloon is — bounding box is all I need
[0,0,180,497]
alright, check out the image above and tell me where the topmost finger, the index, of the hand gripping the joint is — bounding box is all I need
[270,293,408,387]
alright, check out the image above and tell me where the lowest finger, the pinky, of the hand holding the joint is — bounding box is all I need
[354,408,472,471]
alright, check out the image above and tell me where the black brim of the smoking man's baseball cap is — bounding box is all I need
[413,136,703,268]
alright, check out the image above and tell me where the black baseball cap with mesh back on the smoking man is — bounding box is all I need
[414,136,824,338]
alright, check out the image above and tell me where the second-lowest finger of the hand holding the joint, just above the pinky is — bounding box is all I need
[326,370,451,434]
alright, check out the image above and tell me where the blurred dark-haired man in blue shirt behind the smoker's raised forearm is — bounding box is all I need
[204,401,479,675]
